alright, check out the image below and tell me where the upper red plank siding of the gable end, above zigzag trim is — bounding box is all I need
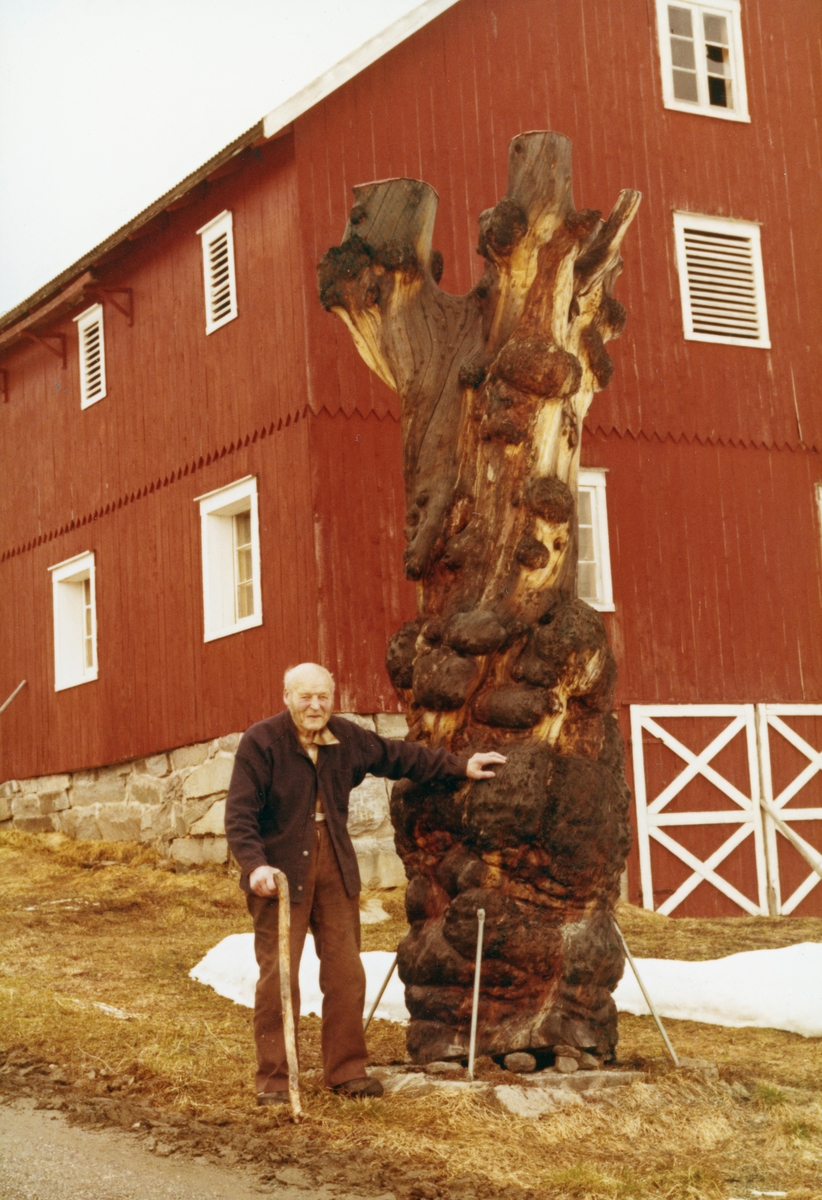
[295,0,822,448]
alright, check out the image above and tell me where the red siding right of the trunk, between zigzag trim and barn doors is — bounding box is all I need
[582,434,822,704]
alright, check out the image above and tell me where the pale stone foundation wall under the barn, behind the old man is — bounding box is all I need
[0,713,408,888]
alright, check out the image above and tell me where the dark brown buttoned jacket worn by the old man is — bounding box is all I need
[226,709,467,902]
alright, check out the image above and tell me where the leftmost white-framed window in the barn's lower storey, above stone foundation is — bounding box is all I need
[49,550,97,691]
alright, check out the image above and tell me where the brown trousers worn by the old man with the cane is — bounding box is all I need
[247,821,366,1092]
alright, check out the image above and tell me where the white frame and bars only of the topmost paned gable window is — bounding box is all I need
[656,0,750,124]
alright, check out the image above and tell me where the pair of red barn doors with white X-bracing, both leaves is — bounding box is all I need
[631,704,822,916]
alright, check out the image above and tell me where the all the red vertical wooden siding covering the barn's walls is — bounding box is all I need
[0,0,822,844]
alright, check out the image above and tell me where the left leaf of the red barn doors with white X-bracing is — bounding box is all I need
[631,704,768,916]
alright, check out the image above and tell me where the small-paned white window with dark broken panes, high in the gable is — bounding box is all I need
[656,0,750,121]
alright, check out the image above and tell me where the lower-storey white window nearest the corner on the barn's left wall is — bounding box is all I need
[197,475,263,642]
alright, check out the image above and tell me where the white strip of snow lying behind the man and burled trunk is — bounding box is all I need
[190,934,822,1038]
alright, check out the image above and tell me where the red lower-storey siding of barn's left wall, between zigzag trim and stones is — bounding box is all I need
[0,429,318,779]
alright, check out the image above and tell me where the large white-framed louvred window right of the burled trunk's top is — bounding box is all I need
[673,212,770,348]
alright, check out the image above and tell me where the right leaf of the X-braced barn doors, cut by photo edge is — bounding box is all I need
[757,704,822,917]
